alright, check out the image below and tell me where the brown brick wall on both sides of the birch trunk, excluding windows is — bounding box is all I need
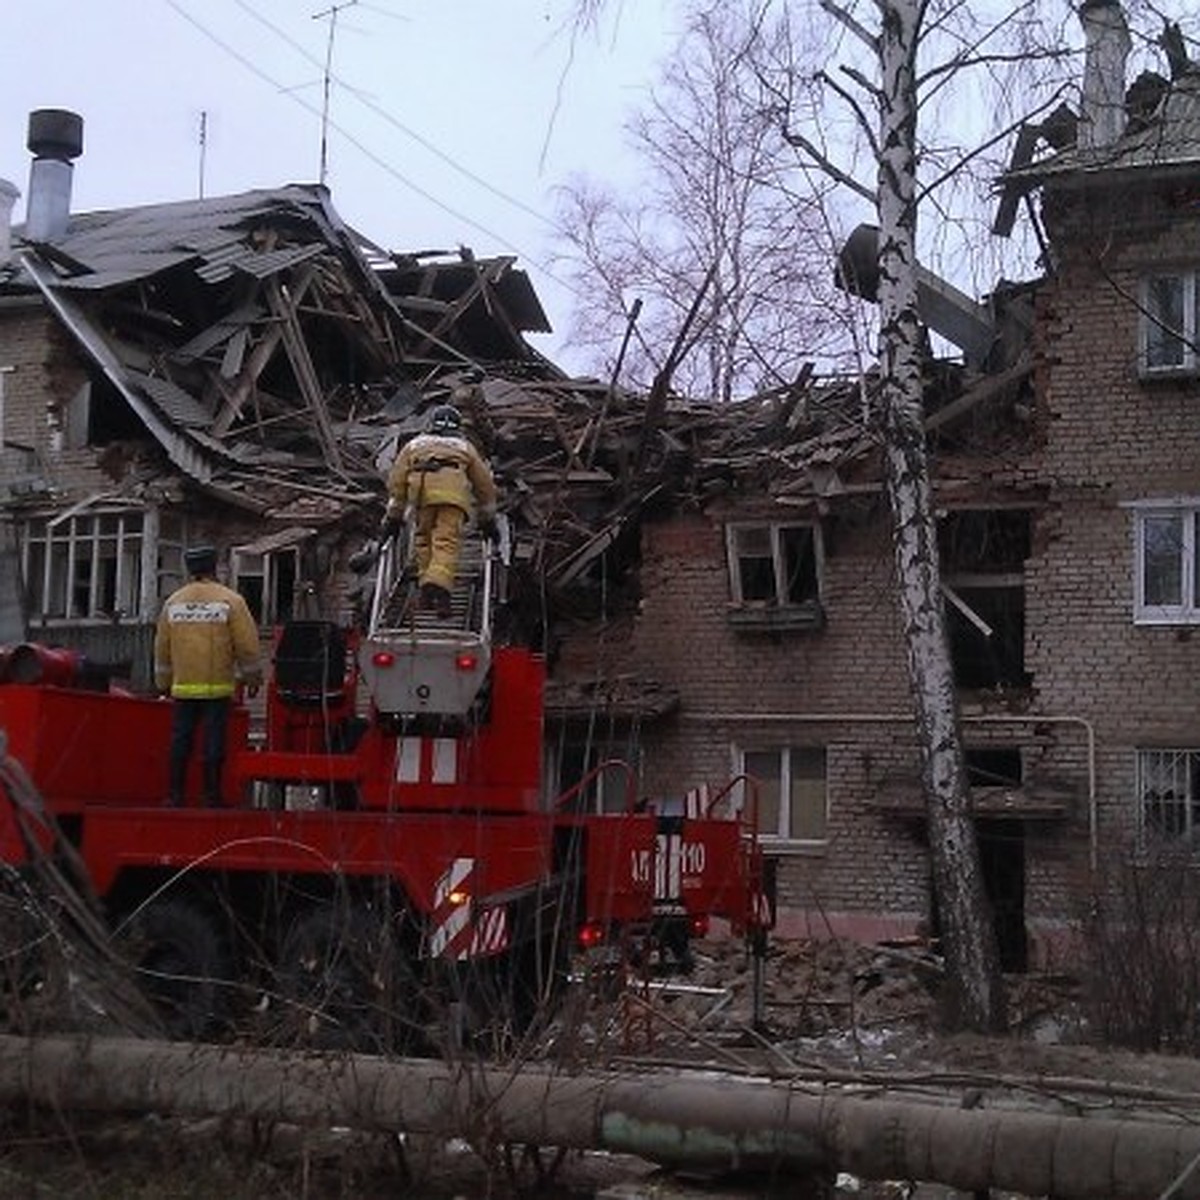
[549,174,1200,960]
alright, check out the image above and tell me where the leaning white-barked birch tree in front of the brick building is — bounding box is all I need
[772,0,1195,1030]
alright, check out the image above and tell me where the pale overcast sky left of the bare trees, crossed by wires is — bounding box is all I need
[0,0,678,366]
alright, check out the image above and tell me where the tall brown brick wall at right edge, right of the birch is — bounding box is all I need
[1027,174,1200,892]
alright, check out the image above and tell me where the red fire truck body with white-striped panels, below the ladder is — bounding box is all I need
[0,609,762,1032]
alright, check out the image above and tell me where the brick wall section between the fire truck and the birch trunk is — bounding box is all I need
[635,506,928,932]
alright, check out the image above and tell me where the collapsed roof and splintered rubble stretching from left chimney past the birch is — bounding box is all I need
[4,166,1027,611]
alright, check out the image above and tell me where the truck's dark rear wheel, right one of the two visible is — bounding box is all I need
[277,905,424,1054]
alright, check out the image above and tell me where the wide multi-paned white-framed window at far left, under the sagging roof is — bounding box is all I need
[20,512,151,620]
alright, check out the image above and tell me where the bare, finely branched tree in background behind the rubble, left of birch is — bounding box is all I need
[549,0,847,400]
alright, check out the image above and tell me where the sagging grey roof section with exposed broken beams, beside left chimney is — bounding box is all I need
[8,185,554,518]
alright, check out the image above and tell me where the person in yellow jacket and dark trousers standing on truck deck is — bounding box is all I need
[154,546,262,806]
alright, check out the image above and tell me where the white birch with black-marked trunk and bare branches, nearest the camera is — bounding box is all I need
[564,0,1200,1028]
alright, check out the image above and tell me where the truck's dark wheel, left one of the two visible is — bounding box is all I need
[118,896,233,1040]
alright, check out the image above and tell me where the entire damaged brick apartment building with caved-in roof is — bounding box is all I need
[0,2,1200,968]
